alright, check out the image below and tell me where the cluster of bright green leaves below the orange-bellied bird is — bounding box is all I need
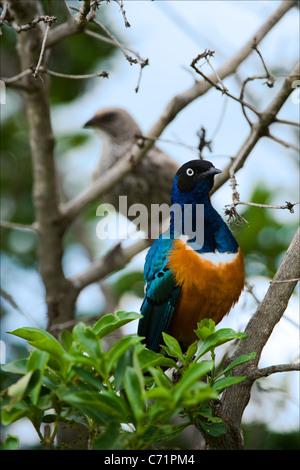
[2,312,253,449]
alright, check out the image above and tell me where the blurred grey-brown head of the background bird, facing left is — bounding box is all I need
[84,107,141,142]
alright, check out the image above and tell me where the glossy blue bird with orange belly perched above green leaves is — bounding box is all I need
[138,160,245,351]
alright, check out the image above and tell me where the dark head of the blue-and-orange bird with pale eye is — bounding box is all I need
[171,160,221,204]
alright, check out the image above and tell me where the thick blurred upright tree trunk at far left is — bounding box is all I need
[9,0,77,330]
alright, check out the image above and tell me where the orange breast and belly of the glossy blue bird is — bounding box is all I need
[168,240,245,345]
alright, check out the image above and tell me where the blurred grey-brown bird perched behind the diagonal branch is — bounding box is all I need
[84,107,179,231]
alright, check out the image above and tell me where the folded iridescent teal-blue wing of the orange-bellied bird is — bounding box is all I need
[138,237,181,351]
